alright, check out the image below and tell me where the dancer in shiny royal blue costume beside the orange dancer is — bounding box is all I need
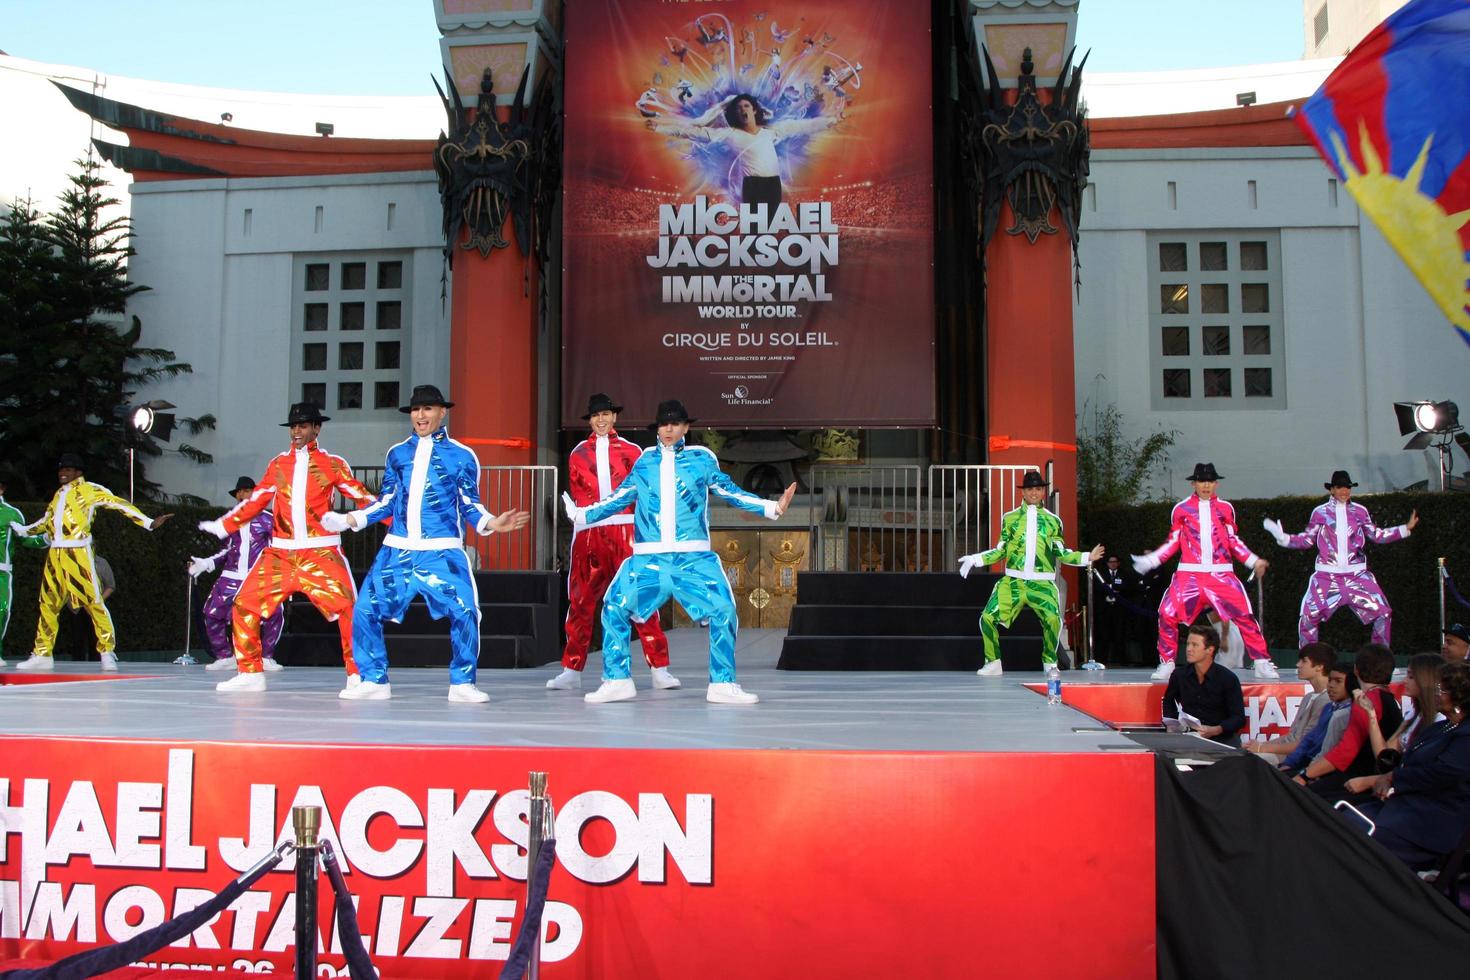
[336,385,531,704]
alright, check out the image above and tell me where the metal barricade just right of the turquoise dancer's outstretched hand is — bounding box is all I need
[807,466,925,572]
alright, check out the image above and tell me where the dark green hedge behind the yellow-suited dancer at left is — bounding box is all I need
[4,502,225,663]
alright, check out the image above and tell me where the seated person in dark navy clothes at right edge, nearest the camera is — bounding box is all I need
[1360,664,1470,871]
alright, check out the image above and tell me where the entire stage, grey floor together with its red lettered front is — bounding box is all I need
[0,627,1346,980]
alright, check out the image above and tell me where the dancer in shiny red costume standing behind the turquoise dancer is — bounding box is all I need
[547,392,679,691]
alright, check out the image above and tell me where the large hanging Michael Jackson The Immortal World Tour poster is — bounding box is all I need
[562,0,933,428]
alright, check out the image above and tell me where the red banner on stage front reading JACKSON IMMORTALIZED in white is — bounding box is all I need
[0,738,1154,979]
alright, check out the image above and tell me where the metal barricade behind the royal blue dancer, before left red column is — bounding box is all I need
[334,466,562,572]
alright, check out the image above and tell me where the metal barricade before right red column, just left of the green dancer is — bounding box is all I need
[925,464,1039,572]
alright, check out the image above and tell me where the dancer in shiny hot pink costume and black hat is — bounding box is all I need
[1133,463,1280,680]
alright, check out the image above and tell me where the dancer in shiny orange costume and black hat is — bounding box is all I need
[200,403,375,693]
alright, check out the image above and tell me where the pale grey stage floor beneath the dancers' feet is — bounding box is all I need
[0,629,1148,752]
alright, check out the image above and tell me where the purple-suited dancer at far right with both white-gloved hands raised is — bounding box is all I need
[1264,470,1419,646]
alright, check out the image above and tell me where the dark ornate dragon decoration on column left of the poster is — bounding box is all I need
[434,66,562,277]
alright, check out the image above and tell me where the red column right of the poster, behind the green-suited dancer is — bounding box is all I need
[985,204,1083,540]
